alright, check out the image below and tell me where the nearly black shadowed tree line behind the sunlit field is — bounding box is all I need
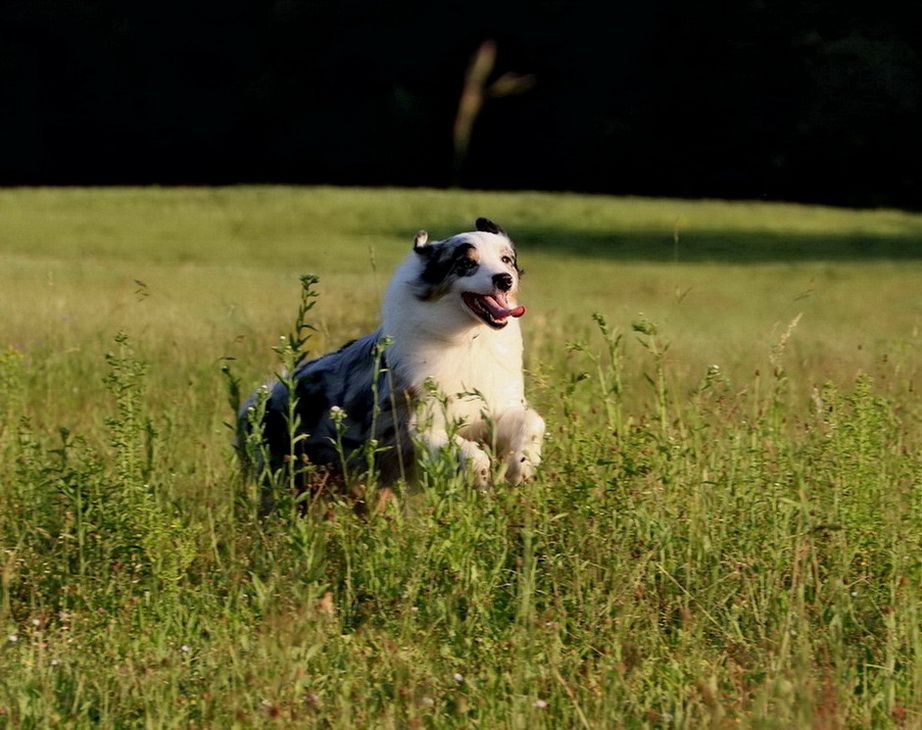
[0,0,922,208]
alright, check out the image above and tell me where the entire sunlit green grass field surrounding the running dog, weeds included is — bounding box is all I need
[0,188,922,728]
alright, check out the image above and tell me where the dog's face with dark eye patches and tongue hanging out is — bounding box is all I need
[413,218,525,330]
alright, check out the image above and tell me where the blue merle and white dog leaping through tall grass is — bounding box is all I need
[240,218,544,486]
